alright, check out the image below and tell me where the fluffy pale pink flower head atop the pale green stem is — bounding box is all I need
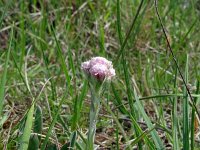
[81,57,115,81]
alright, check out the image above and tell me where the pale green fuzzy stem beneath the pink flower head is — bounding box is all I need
[86,85,100,150]
